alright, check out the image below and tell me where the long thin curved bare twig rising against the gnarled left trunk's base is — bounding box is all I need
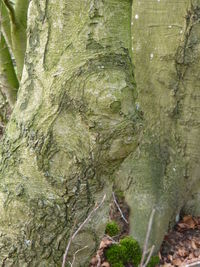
[62,194,106,267]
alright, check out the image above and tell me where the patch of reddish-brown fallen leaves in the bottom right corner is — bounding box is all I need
[160,215,200,267]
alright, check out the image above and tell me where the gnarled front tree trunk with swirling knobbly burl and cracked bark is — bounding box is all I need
[0,0,139,267]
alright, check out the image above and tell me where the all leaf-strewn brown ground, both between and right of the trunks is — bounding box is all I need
[90,195,200,267]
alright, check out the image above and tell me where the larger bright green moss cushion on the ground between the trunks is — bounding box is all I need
[105,237,142,267]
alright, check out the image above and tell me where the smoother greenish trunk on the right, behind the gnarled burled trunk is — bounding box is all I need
[117,0,200,251]
